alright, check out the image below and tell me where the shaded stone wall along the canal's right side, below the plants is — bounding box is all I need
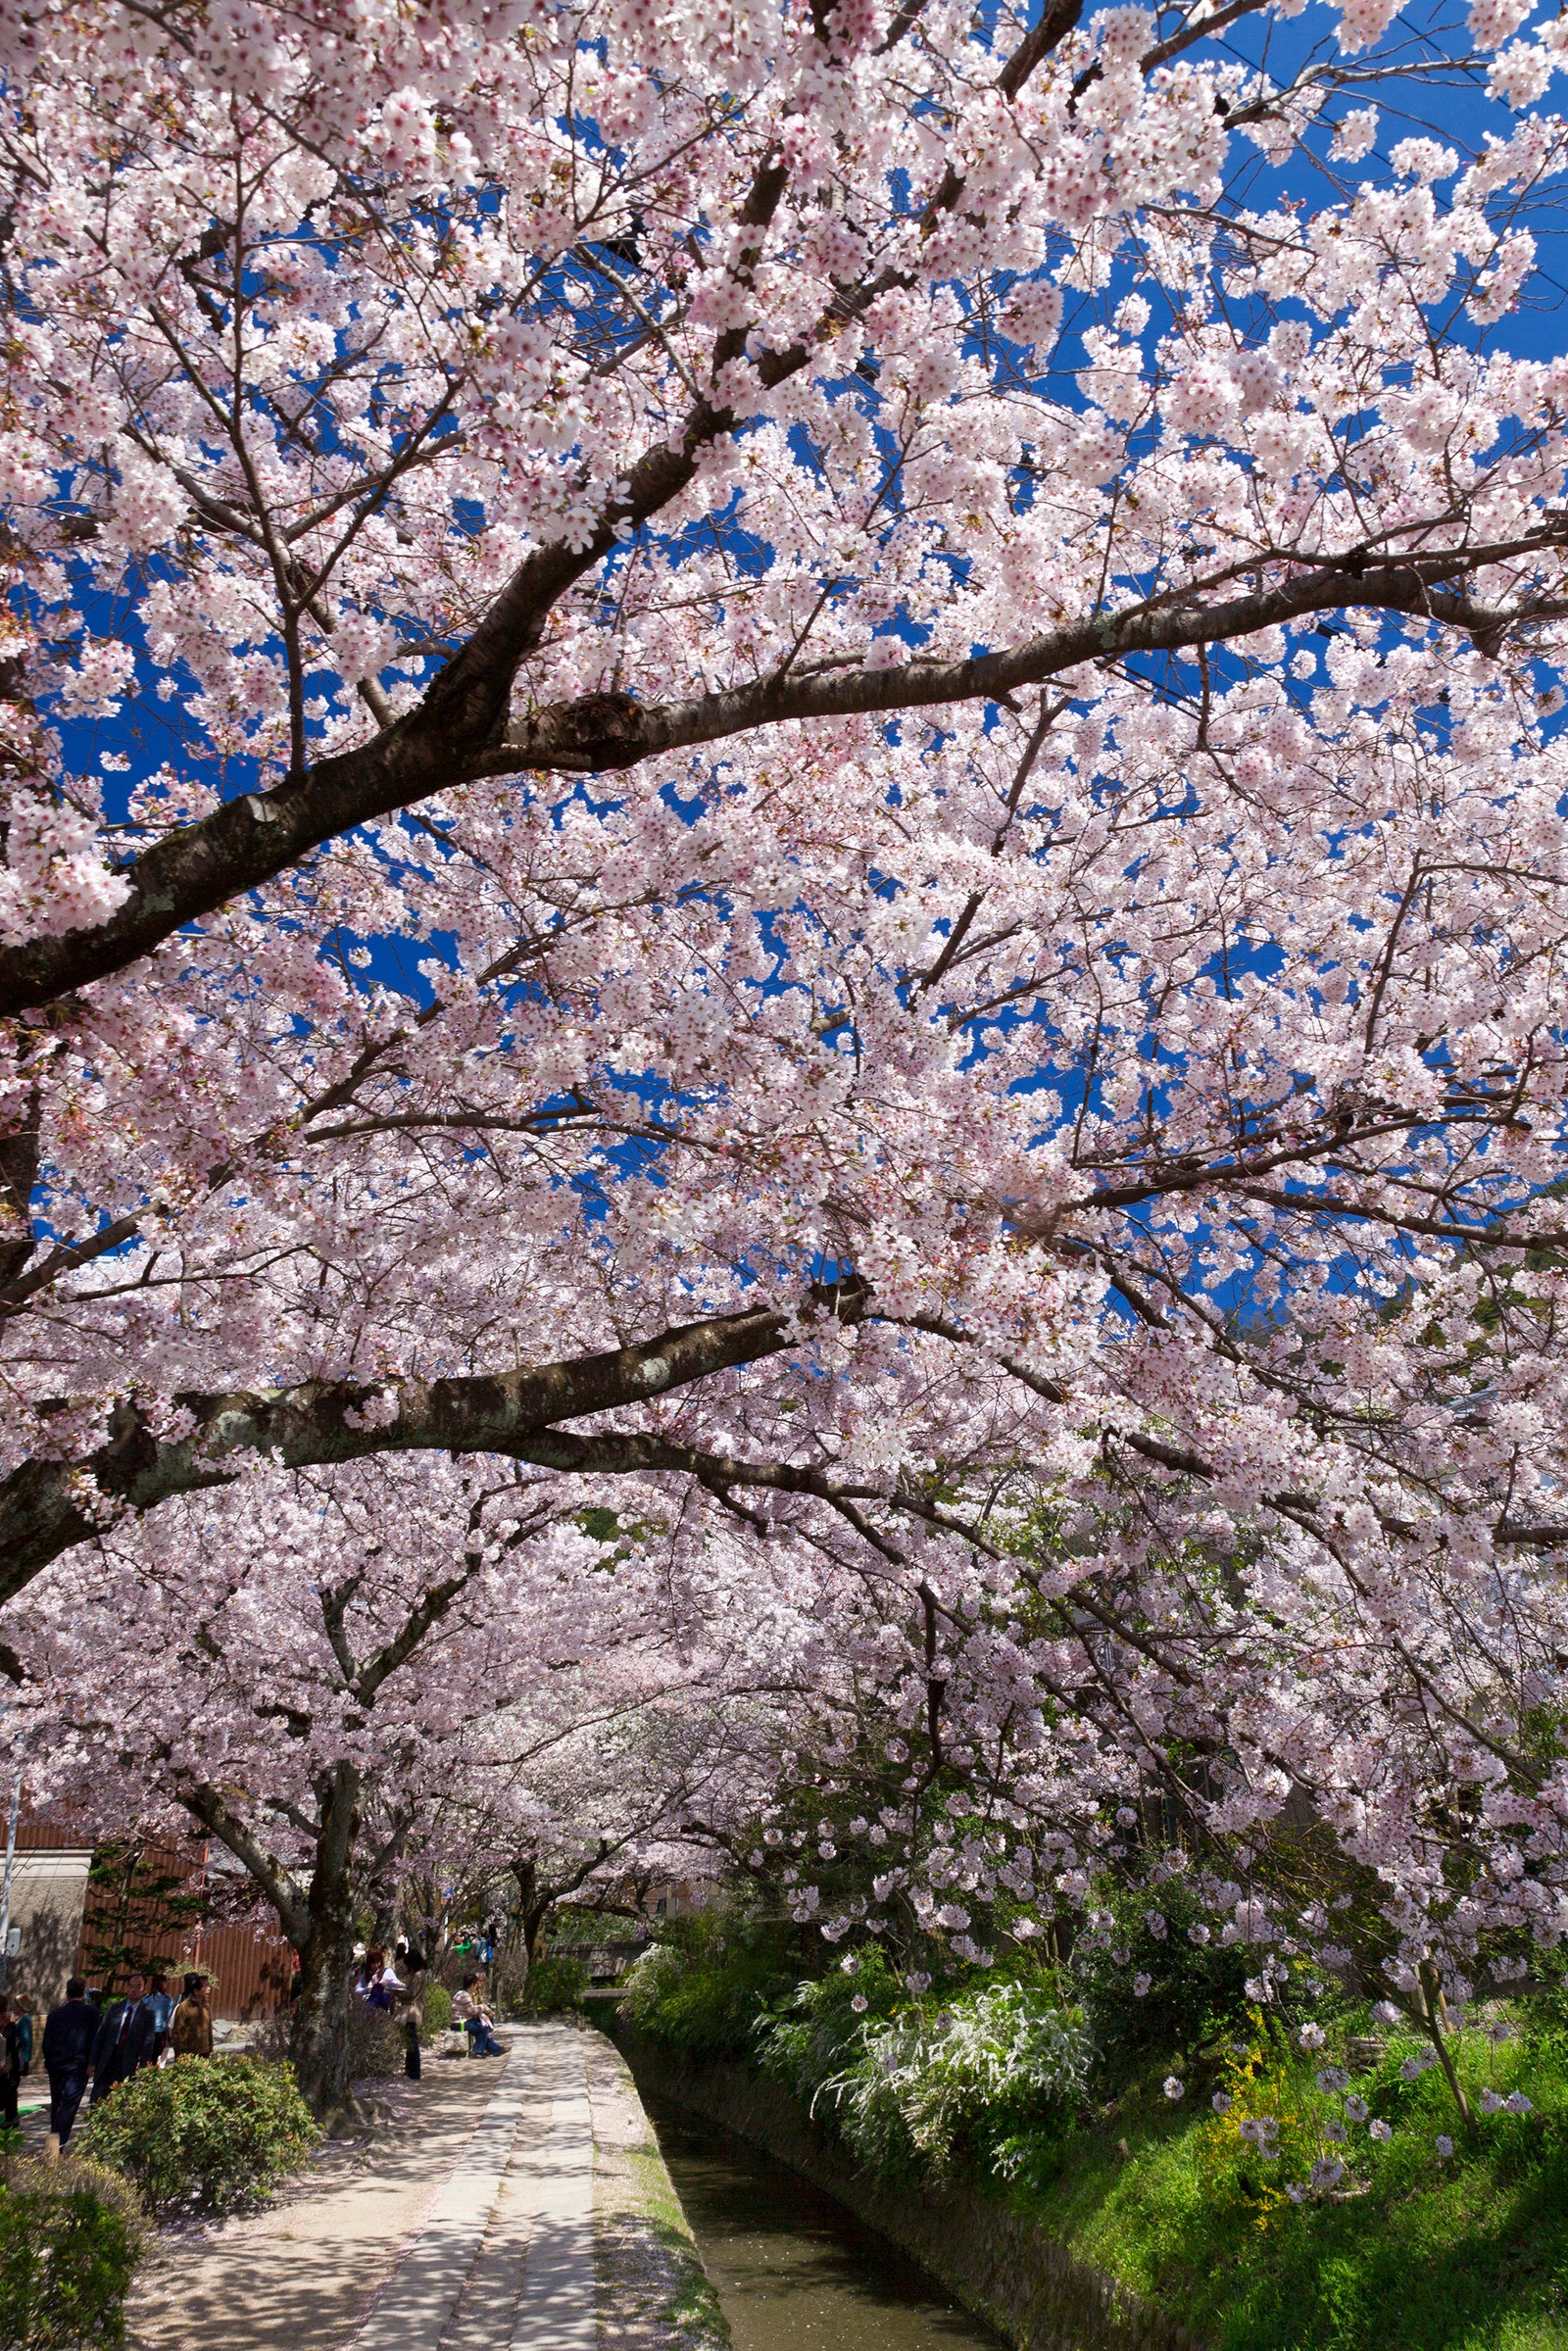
[612,2017,1203,2351]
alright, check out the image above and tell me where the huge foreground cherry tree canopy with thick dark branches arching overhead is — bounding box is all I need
[0,0,1568,2049]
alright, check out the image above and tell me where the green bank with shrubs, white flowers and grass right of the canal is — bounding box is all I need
[627,1926,1568,2351]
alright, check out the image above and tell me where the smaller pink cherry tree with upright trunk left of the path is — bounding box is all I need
[12,1460,780,2111]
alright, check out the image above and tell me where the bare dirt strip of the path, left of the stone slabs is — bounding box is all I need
[129,2057,501,2351]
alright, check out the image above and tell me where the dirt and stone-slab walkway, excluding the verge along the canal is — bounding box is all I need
[131,2025,600,2351]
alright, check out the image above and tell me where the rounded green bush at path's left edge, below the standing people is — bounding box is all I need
[82,2057,319,2212]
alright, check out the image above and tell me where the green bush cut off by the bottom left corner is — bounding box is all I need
[0,2156,146,2351]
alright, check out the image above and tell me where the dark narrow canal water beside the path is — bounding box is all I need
[644,2097,1002,2351]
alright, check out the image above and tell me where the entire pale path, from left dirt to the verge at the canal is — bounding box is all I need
[129,2020,729,2351]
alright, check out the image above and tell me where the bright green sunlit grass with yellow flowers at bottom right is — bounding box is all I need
[1018,2036,1568,2351]
